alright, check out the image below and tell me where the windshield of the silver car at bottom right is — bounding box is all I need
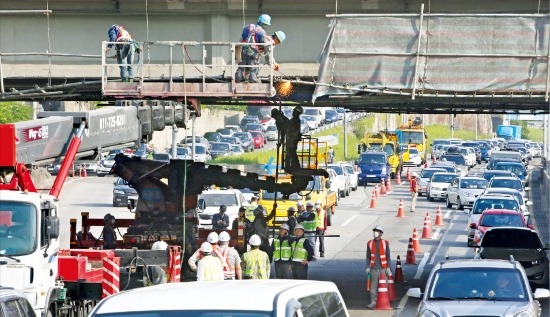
[428,267,529,302]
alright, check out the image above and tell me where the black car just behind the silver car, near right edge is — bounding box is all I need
[477,227,550,288]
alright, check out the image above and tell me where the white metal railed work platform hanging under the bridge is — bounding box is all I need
[101,41,275,99]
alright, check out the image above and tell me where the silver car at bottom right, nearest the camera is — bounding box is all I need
[407,258,550,317]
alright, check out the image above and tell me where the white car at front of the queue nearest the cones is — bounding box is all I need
[447,176,488,210]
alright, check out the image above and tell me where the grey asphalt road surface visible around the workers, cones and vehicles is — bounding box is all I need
[60,157,550,316]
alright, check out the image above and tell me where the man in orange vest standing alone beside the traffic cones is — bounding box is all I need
[366,225,392,309]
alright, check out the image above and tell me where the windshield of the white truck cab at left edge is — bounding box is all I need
[0,201,38,255]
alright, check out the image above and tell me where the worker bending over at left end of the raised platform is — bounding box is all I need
[105,24,135,82]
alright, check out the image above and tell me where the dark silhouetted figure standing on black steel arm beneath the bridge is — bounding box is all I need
[271,106,304,173]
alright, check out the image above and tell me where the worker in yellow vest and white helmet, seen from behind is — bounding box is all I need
[243,234,271,280]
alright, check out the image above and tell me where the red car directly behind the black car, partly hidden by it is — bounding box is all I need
[470,209,533,246]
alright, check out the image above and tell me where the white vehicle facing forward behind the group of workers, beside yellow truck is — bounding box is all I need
[197,189,248,229]
